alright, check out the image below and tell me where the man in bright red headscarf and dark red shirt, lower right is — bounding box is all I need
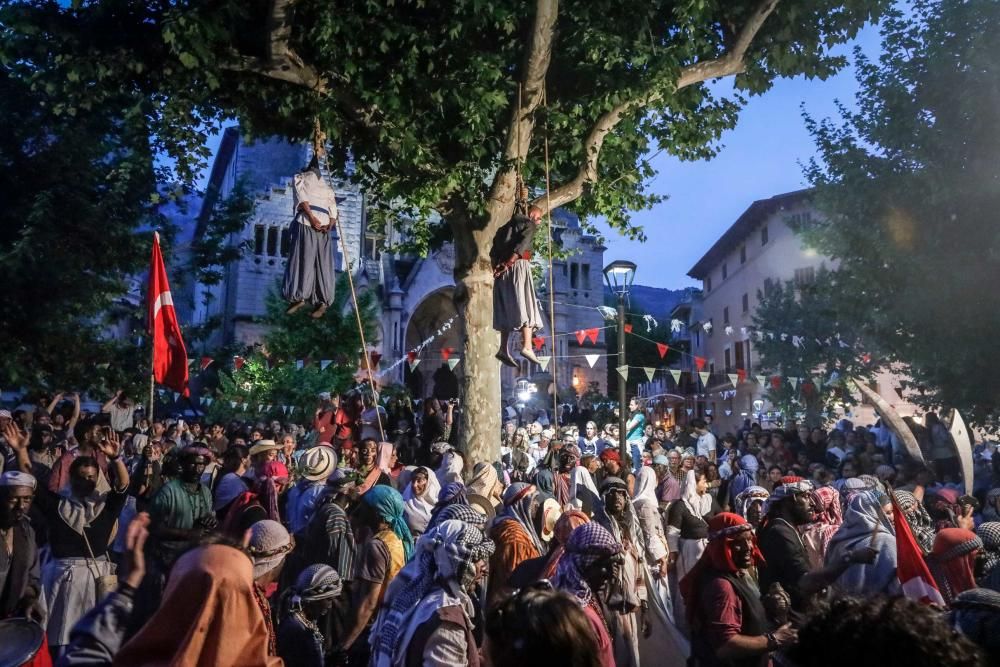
[680,512,796,667]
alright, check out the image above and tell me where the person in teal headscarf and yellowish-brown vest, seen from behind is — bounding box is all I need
[335,484,413,665]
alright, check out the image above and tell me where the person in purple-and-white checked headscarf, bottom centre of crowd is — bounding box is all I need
[555,522,623,667]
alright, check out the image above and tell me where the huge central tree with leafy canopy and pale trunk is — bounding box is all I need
[0,0,888,461]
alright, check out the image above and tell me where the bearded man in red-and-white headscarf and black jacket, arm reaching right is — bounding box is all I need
[760,477,878,620]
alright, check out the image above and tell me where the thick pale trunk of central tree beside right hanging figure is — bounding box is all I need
[447,171,517,469]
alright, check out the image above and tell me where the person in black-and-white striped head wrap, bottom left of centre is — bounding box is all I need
[278,563,343,667]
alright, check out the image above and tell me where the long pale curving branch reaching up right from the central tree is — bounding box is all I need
[532,0,779,211]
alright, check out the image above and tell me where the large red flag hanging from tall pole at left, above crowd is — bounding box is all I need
[146,232,190,396]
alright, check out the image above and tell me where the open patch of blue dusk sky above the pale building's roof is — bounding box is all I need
[598,21,879,289]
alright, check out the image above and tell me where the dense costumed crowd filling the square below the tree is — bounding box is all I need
[0,392,1000,667]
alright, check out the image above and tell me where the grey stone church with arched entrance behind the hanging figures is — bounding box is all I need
[179,128,607,401]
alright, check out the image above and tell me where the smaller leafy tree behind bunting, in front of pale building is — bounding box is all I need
[753,269,883,424]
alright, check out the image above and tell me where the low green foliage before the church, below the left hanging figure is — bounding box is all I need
[208,275,378,419]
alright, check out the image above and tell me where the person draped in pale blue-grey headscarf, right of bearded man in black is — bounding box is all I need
[825,491,900,596]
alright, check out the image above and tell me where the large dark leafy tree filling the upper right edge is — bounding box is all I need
[800,0,1000,425]
